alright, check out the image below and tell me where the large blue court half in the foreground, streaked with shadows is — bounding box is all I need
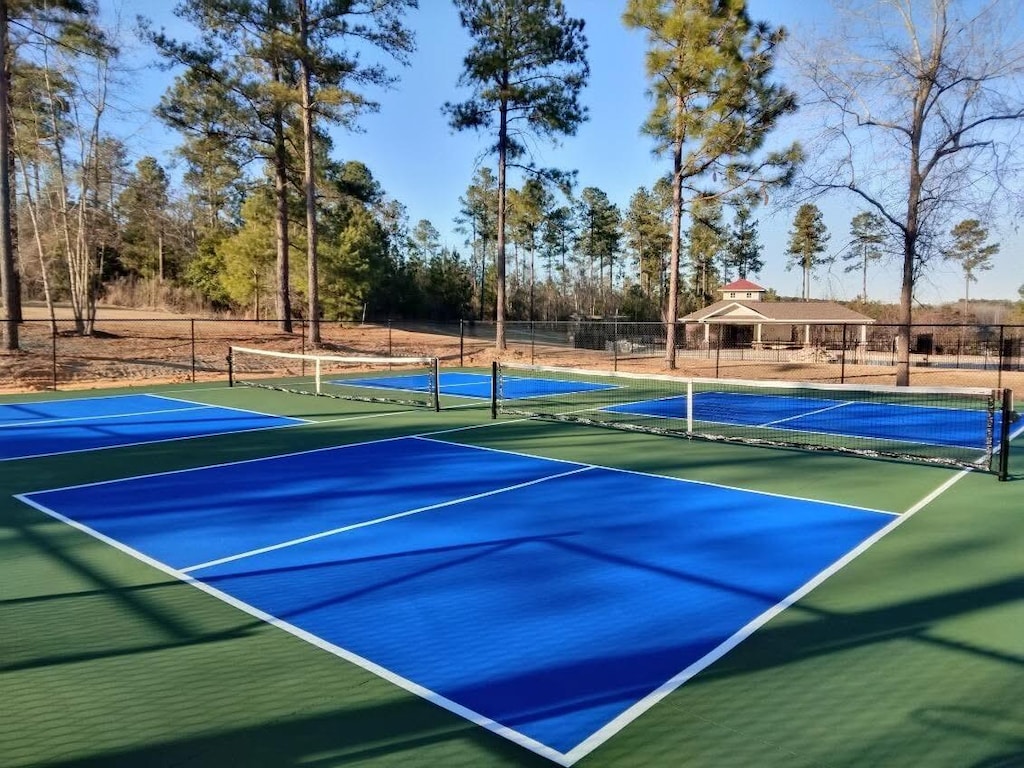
[18,437,896,765]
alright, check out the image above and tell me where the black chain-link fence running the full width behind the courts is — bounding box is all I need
[0,316,1024,391]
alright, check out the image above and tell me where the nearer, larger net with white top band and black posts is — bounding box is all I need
[493,362,1013,471]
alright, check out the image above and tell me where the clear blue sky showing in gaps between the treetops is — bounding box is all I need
[110,0,1024,303]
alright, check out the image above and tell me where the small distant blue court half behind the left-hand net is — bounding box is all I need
[331,373,615,399]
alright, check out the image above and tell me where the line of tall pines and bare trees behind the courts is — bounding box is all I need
[0,0,1024,383]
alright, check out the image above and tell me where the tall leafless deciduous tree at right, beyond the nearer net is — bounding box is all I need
[799,0,1024,385]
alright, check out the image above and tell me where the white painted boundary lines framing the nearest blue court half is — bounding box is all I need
[15,420,1024,767]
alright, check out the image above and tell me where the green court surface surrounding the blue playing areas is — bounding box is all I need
[0,378,1024,768]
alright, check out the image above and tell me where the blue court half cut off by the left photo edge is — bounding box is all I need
[0,394,304,461]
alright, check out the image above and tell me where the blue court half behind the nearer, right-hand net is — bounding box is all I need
[602,392,999,451]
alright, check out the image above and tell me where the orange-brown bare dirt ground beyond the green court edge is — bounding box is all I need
[0,304,1024,392]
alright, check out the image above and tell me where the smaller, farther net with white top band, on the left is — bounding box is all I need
[227,346,440,411]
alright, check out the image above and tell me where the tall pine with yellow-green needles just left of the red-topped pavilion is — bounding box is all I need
[623,0,801,369]
